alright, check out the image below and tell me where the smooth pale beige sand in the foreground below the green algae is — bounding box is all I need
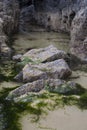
[21,106,87,130]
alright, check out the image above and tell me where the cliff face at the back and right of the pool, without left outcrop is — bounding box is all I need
[20,0,87,59]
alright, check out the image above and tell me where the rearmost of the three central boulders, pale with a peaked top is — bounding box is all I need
[22,45,67,62]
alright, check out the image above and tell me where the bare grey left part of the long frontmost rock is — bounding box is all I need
[7,80,45,99]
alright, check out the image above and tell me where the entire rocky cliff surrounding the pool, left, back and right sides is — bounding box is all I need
[0,0,87,59]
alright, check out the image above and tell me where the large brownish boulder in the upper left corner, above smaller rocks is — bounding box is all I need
[3,0,20,35]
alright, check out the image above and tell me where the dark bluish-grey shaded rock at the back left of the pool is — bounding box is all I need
[19,5,36,32]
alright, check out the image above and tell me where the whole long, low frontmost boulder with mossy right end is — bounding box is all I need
[6,79,85,101]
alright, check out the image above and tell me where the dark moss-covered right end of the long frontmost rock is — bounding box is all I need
[45,81,85,95]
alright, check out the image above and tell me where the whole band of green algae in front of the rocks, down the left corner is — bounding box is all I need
[0,88,87,130]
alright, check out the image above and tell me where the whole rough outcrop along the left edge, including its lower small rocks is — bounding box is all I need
[0,0,19,57]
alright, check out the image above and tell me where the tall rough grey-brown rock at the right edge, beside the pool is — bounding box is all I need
[71,7,87,59]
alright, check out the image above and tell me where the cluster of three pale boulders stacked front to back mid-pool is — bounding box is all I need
[8,45,84,98]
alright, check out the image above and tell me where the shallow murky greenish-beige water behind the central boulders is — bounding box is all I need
[13,32,69,53]
